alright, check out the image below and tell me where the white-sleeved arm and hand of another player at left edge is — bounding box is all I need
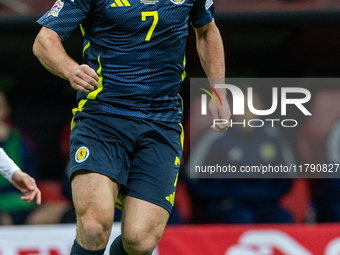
[0,148,41,205]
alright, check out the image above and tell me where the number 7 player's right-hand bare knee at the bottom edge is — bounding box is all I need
[123,233,161,255]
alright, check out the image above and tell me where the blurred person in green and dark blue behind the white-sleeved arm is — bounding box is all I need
[0,91,37,224]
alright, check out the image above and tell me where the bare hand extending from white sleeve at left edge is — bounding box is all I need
[12,171,41,205]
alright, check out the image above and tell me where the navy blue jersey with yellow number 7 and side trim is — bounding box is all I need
[38,0,215,122]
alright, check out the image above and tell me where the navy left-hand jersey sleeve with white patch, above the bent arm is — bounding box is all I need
[37,0,91,39]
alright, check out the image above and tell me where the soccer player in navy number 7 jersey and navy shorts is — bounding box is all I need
[33,0,230,255]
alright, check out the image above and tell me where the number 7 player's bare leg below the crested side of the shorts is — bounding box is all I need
[71,170,119,251]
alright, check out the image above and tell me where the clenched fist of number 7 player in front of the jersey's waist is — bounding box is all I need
[69,64,99,93]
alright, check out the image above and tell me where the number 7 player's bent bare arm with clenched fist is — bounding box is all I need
[33,27,98,93]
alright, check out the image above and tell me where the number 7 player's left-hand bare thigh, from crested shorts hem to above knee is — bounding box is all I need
[71,170,119,221]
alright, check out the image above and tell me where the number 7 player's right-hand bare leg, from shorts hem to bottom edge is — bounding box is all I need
[119,196,169,255]
